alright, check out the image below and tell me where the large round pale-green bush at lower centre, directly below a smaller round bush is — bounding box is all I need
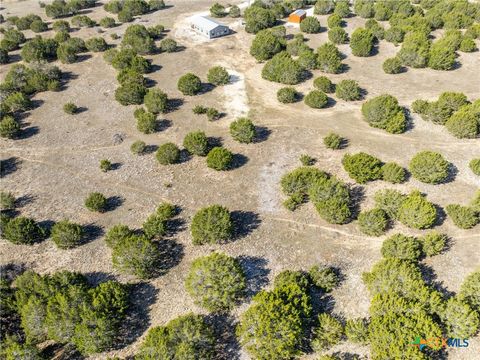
[185,253,246,312]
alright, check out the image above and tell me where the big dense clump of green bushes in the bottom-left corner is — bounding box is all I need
[7,271,129,355]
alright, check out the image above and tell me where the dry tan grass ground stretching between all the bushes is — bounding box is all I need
[0,0,480,360]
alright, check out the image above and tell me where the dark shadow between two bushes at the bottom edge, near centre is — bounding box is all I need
[205,314,240,360]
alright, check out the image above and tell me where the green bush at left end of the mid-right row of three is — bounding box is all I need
[342,152,382,184]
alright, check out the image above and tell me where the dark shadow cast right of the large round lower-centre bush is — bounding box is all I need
[238,255,270,300]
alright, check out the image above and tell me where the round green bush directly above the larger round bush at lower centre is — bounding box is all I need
[190,205,234,245]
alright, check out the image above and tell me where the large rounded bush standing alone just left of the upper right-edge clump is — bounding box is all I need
[362,94,407,134]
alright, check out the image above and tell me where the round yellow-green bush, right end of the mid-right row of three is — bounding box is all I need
[408,151,450,184]
